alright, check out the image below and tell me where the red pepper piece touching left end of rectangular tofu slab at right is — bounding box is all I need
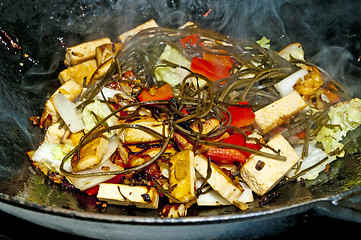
[227,102,255,127]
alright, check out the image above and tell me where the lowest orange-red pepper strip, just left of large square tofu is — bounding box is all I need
[207,146,246,164]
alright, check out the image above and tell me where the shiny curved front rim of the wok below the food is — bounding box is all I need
[0,186,352,225]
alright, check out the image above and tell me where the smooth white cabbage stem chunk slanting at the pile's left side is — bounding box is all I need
[52,92,84,133]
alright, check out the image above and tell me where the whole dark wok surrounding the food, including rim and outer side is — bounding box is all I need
[0,0,361,239]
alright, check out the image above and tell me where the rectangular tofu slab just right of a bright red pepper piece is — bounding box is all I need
[254,91,307,134]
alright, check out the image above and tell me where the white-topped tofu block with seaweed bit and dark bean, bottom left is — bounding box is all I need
[97,183,159,209]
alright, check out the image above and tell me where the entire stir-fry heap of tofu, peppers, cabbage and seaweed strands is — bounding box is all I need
[28,20,361,217]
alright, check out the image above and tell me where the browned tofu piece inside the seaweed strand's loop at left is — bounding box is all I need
[71,135,109,172]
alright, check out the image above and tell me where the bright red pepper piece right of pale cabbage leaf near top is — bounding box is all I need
[191,57,229,81]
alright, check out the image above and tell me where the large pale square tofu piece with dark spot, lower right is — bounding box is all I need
[240,134,300,196]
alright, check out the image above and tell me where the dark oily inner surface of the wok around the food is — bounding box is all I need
[0,0,361,217]
